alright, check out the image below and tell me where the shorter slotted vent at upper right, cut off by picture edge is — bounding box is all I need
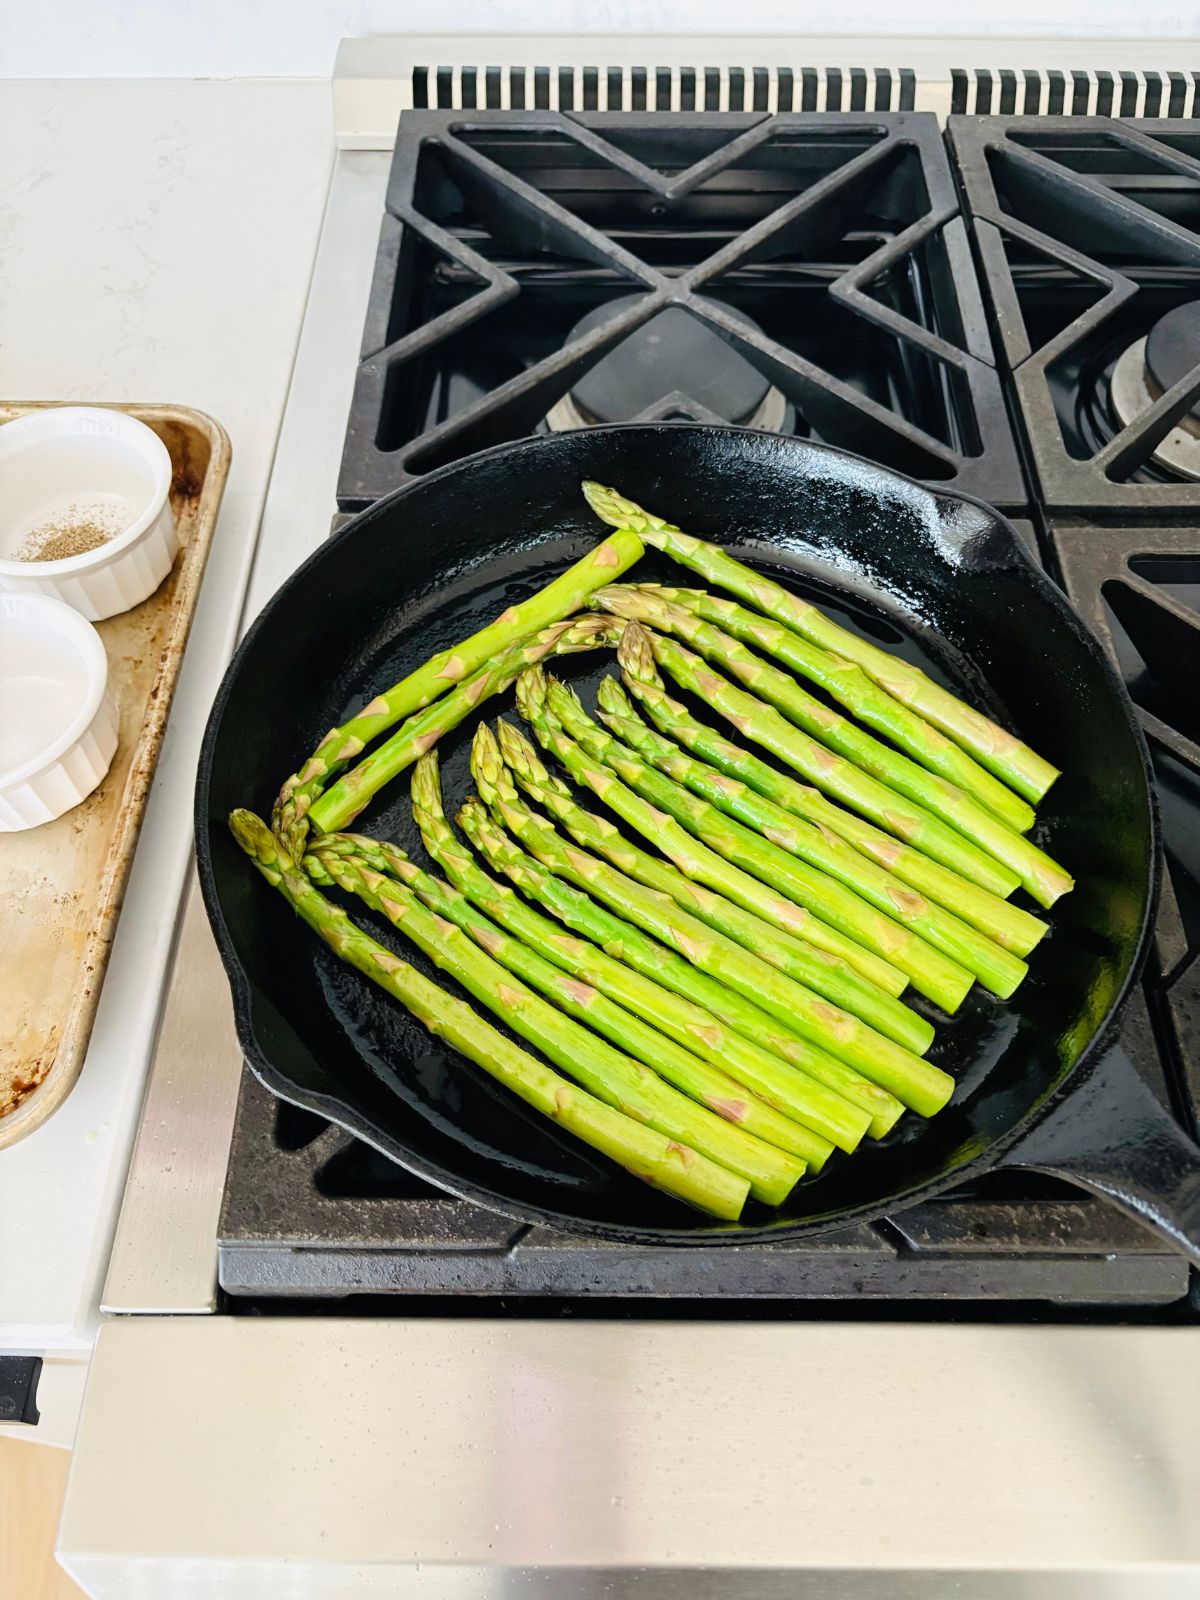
[950,67,1200,117]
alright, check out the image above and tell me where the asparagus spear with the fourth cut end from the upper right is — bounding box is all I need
[620,629,1021,894]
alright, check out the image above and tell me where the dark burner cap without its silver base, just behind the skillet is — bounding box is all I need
[570,294,771,422]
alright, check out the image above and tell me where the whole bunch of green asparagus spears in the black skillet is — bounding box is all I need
[230,483,1072,1221]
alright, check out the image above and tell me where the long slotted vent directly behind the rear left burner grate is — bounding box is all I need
[413,66,917,112]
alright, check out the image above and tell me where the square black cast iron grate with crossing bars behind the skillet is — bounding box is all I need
[338,110,1027,509]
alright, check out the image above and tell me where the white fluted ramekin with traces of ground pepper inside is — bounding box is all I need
[0,406,179,622]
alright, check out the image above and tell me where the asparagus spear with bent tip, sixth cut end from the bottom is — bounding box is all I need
[470,723,954,1117]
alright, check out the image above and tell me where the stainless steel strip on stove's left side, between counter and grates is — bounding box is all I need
[101,152,389,1312]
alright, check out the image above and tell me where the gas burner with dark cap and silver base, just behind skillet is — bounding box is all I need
[546,294,787,434]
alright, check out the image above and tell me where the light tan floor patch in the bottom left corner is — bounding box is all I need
[0,1438,83,1600]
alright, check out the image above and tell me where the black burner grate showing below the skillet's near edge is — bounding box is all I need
[219,1036,1187,1315]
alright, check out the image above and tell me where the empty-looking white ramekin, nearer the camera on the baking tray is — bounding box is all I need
[0,594,117,834]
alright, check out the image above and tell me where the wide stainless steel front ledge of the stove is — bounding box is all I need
[59,1317,1200,1600]
